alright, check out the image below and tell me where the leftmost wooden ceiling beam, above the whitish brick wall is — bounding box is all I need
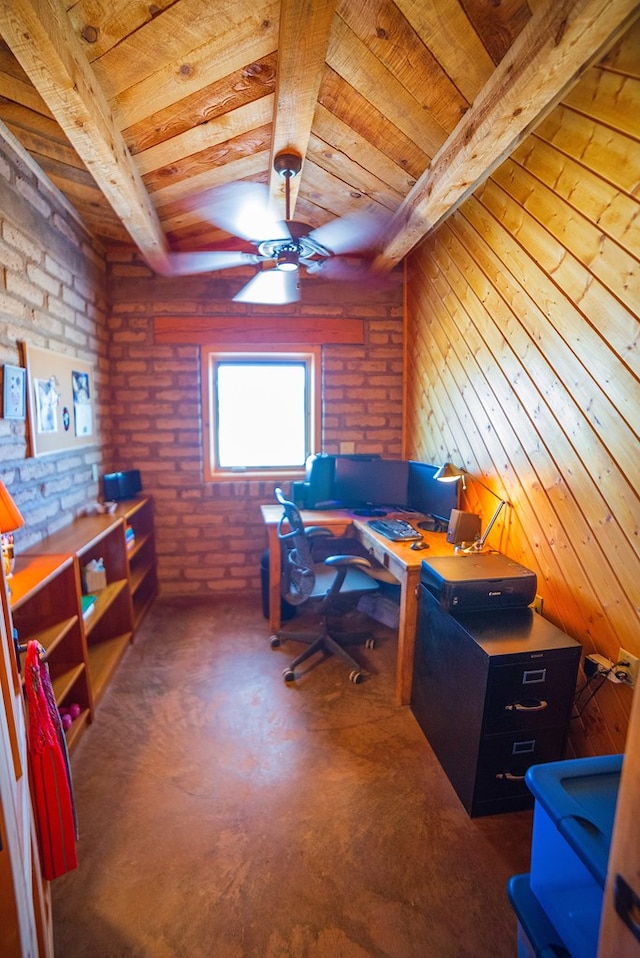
[0,0,169,272]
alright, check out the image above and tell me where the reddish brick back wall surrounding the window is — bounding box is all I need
[107,253,403,593]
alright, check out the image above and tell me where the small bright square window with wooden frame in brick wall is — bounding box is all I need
[202,349,320,479]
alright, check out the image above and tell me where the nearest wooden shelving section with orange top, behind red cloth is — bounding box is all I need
[9,554,93,751]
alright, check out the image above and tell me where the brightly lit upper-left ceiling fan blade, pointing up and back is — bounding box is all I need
[198,183,291,243]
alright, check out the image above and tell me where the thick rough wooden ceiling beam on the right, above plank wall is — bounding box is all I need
[374,0,640,271]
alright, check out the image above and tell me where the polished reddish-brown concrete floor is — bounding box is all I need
[53,597,532,958]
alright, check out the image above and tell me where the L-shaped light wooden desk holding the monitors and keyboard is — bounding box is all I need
[260,504,453,705]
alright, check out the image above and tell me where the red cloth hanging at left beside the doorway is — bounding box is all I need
[25,641,78,881]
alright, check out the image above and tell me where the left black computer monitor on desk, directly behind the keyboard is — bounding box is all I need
[333,456,409,509]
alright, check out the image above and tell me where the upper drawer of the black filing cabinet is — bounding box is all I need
[483,655,579,735]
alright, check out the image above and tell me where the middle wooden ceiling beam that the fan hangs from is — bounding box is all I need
[269,0,335,219]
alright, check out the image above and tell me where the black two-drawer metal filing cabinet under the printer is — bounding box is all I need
[411,585,581,816]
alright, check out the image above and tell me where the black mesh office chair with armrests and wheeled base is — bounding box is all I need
[271,488,389,685]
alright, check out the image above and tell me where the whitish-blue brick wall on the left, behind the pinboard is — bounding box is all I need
[0,135,108,554]
